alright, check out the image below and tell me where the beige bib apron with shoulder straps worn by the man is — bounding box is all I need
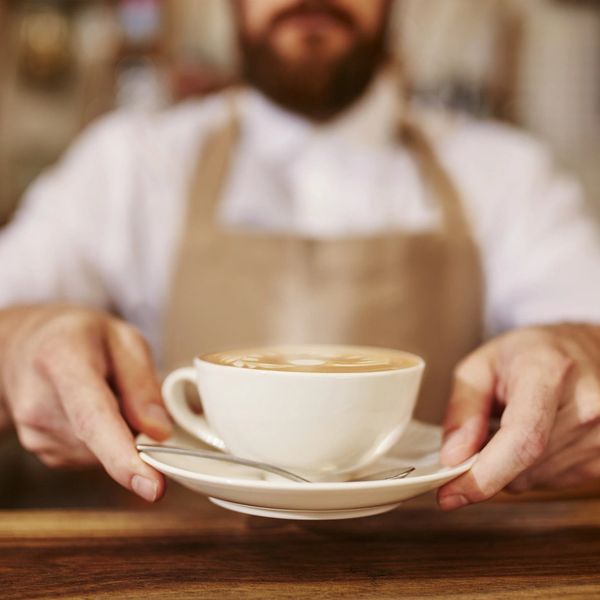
[163,101,482,423]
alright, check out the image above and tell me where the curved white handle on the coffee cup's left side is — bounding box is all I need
[162,367,226,450]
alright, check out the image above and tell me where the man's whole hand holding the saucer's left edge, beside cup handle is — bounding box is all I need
[0,307,171,501]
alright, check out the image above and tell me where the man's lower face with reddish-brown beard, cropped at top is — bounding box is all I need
[234,0,391,119]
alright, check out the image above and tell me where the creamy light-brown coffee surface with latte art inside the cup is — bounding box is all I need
[202,346,419,373]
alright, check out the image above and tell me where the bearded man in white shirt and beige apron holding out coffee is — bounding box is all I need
[0,0,600,509]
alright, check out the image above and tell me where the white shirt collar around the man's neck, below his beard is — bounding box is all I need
[240,72,400,161]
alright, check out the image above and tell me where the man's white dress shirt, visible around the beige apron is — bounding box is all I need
[0,77,600,350]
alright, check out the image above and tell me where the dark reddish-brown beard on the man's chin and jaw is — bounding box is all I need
[239,26,388,121]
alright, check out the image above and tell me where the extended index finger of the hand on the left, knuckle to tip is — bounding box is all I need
[42,345,164,502]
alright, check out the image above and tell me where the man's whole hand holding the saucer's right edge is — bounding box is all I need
[438,325,600,510]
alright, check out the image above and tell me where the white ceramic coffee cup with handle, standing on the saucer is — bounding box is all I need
[163,346,425,480]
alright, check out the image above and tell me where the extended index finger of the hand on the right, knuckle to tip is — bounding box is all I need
[438,352,569,510]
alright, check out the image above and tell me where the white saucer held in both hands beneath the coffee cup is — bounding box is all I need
[137,421,476,520]
